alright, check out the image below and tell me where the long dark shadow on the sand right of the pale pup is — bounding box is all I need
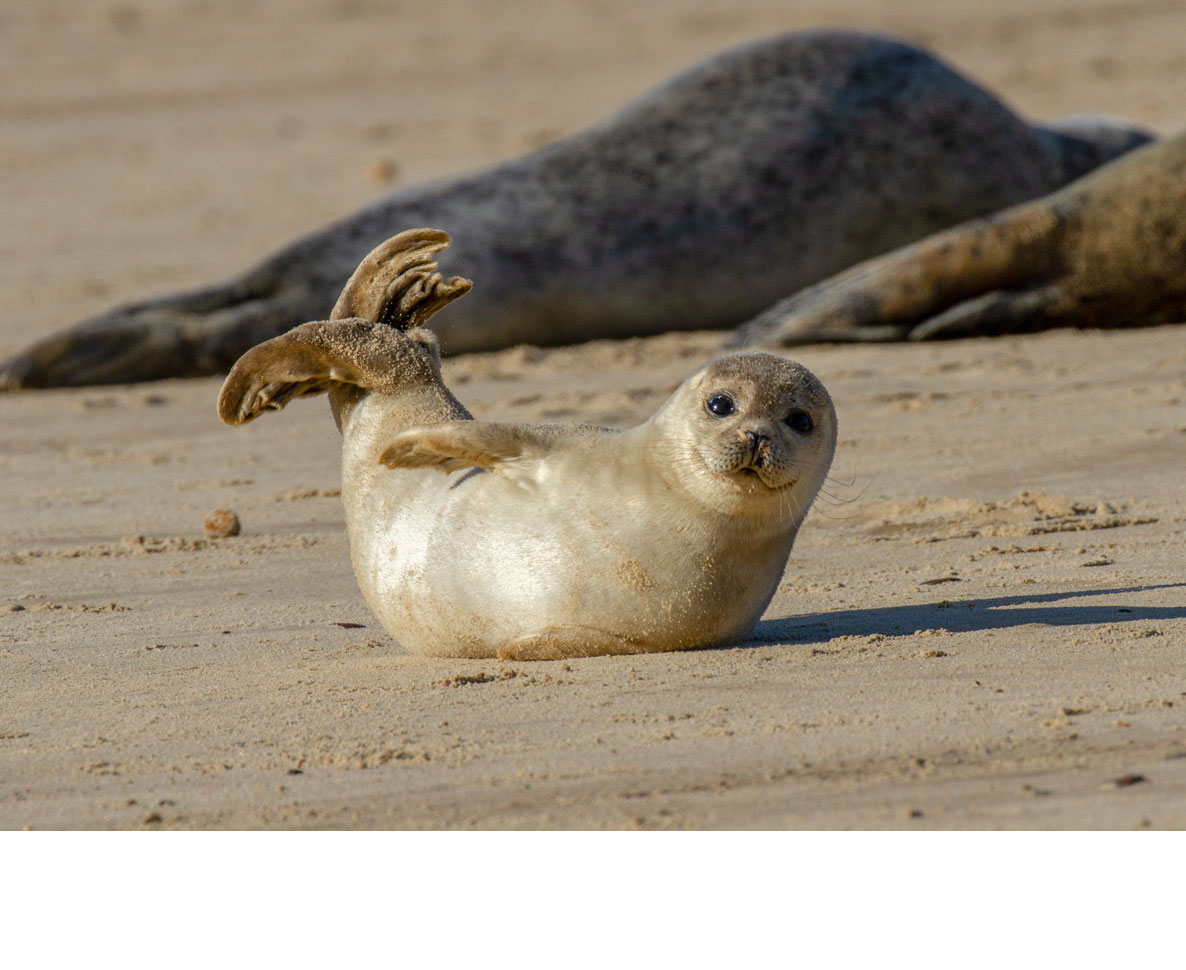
[740,582,1186,646]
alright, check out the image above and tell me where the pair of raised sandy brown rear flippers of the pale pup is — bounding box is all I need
[218,229,471,425]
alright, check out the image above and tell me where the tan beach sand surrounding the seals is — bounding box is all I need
[0,0,1186,829]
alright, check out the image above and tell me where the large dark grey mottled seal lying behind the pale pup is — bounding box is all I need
[0,31,1148,388]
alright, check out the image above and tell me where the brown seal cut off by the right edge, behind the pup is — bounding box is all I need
[738,135,1186,345]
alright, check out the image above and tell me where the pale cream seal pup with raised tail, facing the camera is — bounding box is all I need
[218,229,836,659]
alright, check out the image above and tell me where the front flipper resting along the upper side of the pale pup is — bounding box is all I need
[380,421,567,477]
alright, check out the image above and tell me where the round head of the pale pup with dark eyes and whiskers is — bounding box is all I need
[649,351,836,528]
